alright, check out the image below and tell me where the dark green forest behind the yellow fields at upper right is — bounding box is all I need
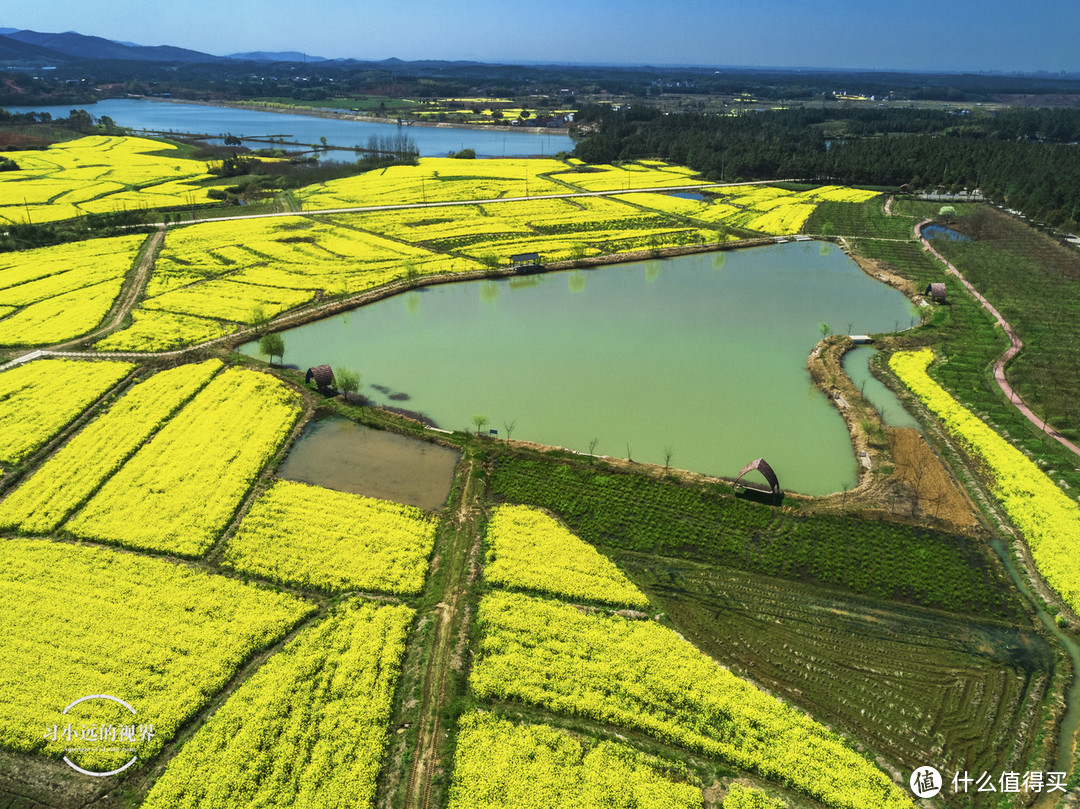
[573,106,1080,229]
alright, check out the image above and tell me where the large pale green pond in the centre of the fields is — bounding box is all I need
[243,242,915,495]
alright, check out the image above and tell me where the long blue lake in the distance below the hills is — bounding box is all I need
[5,98,573,160]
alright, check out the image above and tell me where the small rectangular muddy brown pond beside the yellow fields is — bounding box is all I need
[278,419,461,511]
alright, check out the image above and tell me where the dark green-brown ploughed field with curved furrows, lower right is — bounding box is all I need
[618,553,1056,794]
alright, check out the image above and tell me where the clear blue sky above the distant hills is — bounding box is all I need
[0,0,1080,72]
